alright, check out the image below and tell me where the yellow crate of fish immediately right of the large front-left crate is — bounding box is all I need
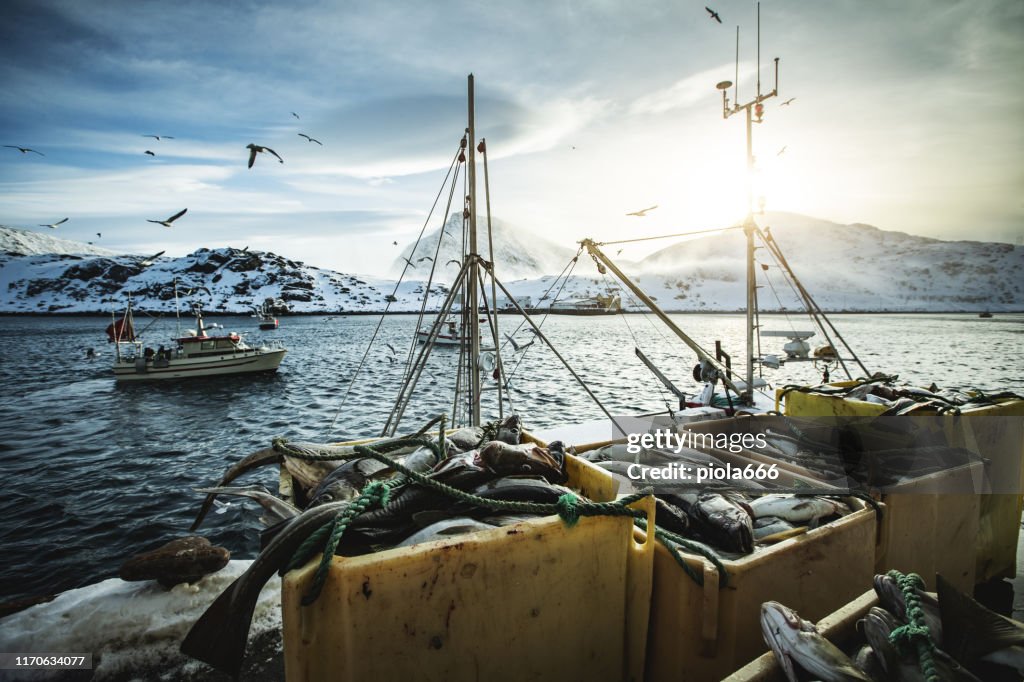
[646,493,876,682]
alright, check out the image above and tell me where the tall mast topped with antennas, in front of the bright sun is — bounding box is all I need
[716,2,778,404]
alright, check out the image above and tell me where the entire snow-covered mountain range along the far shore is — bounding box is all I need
[0,213,1024,313]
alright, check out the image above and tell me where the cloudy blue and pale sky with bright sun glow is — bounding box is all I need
[0,0,1024,273]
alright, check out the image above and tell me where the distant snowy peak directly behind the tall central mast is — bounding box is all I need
[392,213,575,283]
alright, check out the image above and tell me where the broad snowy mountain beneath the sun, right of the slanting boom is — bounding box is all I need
[622,213,1024,310]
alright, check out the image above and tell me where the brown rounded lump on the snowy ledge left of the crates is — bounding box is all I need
[118,536,231,588]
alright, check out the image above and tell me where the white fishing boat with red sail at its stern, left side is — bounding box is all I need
[106,298,287,381]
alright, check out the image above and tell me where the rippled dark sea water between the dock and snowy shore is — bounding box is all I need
[0,314,1024,601]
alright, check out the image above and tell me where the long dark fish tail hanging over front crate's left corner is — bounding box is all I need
[181,502,345,678]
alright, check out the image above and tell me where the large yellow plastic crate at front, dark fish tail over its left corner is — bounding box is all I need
[282,450,653,682]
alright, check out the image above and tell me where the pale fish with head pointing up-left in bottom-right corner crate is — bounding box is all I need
[761,601,870,682]
